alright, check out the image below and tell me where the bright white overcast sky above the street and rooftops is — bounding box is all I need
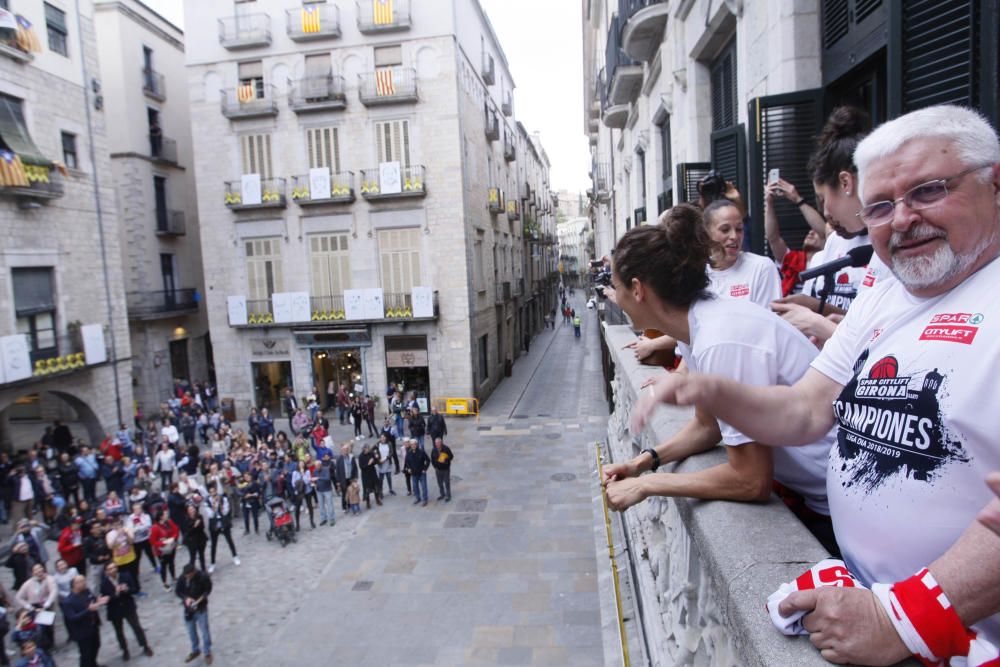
[143,0,590,192]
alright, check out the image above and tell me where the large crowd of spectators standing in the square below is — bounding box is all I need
[0,383,454,667]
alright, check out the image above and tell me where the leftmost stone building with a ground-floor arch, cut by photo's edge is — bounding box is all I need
[0,0,132,450]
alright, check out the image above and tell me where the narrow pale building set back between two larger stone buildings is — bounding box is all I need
[94,0,211,413]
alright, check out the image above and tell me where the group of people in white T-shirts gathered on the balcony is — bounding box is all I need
[602,105,1000,667]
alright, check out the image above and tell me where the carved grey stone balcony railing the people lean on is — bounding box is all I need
[604,325,829,667]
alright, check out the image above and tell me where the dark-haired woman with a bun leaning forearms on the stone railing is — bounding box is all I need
[603,205,835,550]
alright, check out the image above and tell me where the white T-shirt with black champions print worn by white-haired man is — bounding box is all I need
[812,253,1000,644]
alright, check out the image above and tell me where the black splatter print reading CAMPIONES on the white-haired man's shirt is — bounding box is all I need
[834,350,969,493]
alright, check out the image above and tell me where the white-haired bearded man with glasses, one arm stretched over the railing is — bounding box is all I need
[632,105,1000,665]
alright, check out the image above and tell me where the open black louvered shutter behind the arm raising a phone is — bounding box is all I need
[742,88,823,253]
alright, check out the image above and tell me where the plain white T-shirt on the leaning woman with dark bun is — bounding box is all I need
[684,299,836,514]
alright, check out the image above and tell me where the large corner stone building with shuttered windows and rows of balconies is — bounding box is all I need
[185,0,554,415]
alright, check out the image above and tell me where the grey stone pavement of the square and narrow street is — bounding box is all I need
[39,298,608,667]
